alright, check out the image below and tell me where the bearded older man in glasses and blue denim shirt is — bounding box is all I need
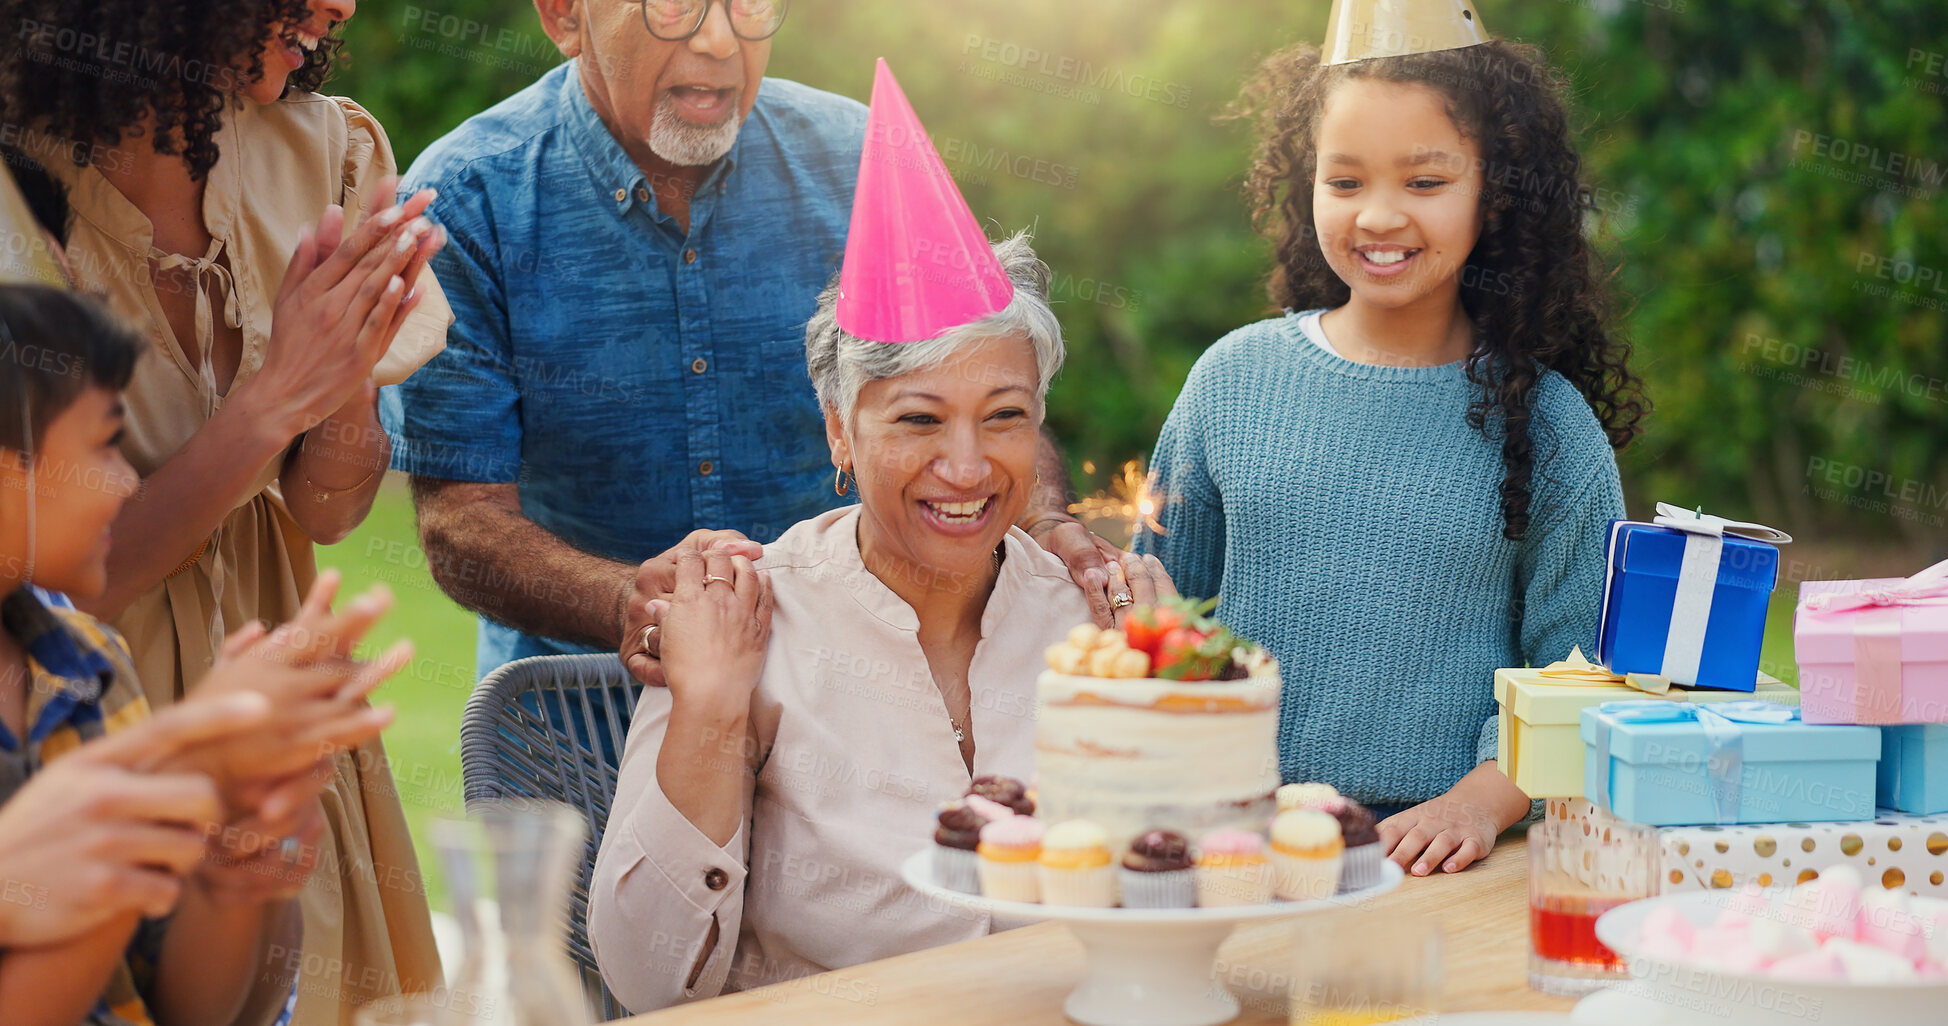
[382,0,1149,681]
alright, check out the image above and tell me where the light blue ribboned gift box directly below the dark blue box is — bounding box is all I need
[1582,699,1880,827]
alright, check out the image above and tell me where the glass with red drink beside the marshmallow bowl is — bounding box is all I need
[1529,820,1658,997]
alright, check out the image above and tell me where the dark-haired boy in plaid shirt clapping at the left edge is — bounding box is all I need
[0,286,409,1026]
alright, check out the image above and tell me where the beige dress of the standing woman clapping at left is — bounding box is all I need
[51,93,452,1026]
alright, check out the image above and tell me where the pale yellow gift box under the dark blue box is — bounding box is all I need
[1494,650,1800,798]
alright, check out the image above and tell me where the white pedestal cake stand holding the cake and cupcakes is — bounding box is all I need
[900,849,1403,1026]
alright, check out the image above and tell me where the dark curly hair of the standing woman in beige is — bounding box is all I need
[0,0,343,179]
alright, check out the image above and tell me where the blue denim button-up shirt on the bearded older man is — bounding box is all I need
[380,60,865,674]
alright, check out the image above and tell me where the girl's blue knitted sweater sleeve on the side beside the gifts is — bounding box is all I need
[1475,446,1623,761]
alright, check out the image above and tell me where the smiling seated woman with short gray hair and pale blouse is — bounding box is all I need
[588,236,1169,1012]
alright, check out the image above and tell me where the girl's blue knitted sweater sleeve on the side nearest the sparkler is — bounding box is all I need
[1136,360,1223,598]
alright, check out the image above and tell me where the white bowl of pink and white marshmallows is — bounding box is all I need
[1578,866,1948,1026]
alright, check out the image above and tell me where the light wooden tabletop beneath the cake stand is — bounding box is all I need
[625,827,1574,1026]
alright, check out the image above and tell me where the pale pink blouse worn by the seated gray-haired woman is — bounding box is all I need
[588,506,1089,1012]
